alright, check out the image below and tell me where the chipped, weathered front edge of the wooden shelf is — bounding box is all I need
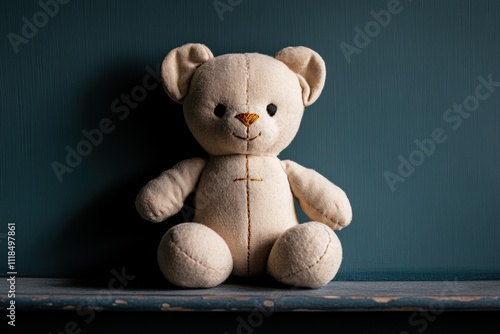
[6,295,500,313]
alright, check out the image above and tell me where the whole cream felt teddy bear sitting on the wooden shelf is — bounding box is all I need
[135,43,352,288]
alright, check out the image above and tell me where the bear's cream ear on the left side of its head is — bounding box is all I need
[161,43,214,103]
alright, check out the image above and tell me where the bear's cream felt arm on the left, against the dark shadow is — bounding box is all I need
[135,158,207,223]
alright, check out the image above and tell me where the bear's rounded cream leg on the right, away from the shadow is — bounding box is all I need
[267,222,342,288]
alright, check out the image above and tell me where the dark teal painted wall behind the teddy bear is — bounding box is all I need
[0,0,500,281]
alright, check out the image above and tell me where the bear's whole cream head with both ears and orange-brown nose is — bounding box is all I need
[162,44,326,156]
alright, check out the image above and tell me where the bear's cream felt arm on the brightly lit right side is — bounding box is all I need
[281,160,352,230]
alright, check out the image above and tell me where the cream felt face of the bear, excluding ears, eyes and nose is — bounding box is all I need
[182,53,304,156]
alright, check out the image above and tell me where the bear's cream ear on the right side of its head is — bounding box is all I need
[274,46,326,107]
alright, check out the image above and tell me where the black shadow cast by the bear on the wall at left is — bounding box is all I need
[53,59,206,286]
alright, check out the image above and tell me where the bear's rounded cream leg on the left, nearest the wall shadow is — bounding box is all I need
[158,223,233,288]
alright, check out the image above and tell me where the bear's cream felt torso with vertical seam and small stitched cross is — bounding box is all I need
[194,155,298,276]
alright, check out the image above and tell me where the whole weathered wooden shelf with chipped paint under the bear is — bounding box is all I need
[0,278,500,312]
